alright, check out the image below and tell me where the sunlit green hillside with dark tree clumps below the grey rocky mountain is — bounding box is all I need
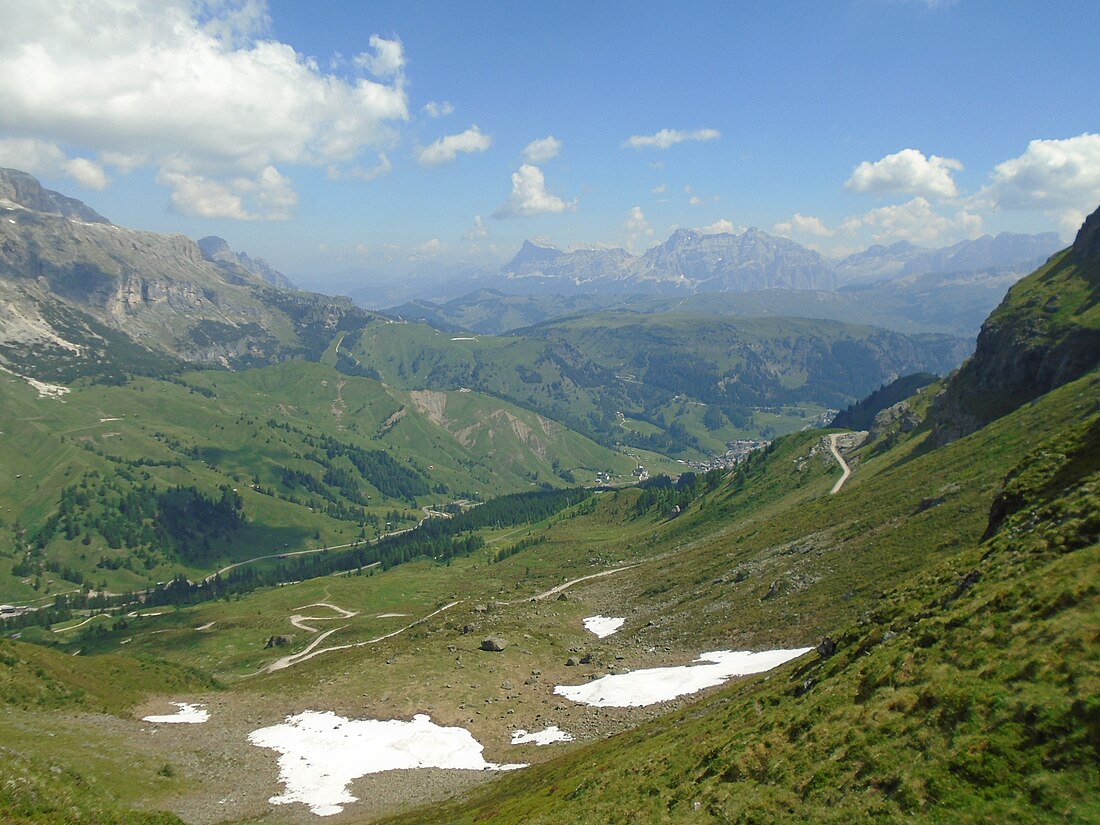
[0,361,655,602]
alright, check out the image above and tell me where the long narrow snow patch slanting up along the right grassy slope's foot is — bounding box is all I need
[553,648,813,707]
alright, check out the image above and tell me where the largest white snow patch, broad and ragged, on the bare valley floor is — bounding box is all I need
[249,711,526,816]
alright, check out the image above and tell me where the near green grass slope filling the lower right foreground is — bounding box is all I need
[380,374,1100,823]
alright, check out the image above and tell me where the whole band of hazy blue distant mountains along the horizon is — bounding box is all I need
[385,229,1060,337]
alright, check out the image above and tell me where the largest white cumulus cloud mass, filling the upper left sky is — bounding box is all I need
[0,0,408,219]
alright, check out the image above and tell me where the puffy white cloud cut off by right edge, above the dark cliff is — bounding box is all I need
[976,133,1100,215]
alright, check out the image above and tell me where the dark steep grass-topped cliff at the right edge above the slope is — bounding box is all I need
[931,209,1100,444]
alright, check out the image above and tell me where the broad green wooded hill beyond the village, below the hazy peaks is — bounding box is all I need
[347,312,966,459]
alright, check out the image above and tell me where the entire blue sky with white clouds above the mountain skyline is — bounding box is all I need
[0,0,1100,288]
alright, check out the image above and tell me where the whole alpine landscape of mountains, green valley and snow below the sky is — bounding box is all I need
[0,169,1100,825]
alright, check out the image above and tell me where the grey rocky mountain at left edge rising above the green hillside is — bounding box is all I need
[0,169,369,382]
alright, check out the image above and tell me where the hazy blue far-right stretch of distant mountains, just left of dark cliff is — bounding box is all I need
[835,232,1062,286]
